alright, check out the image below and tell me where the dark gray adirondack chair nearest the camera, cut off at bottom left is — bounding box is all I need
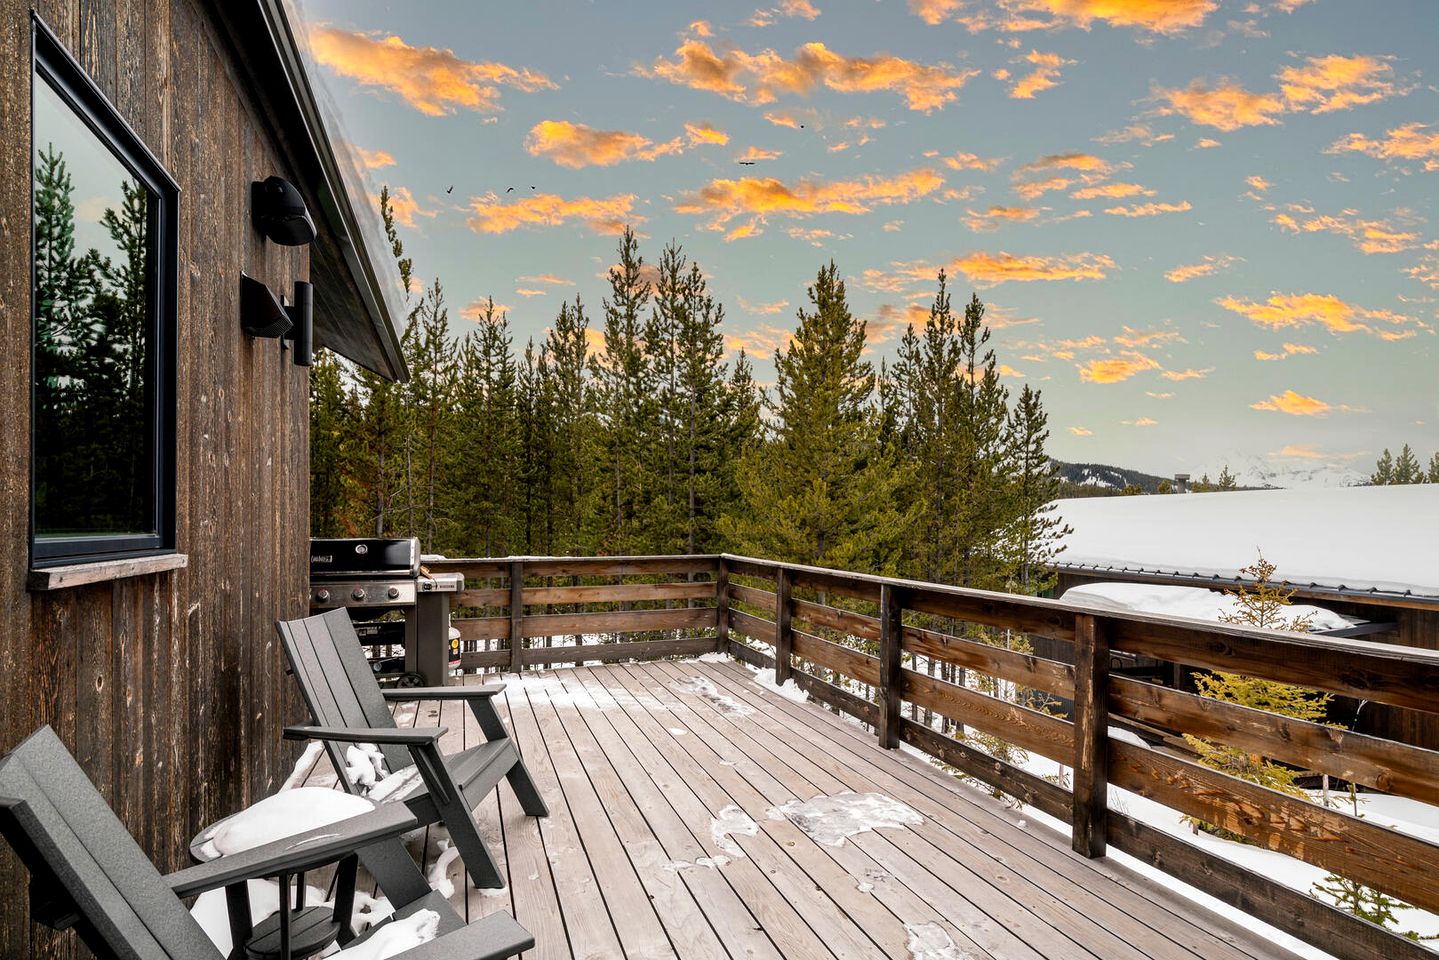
[0,727,534,960]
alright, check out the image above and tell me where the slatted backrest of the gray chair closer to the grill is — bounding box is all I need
[275,607,410,786]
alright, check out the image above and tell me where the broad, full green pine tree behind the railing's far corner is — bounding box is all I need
[722,262,908,573]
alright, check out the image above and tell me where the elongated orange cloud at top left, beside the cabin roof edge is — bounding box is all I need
[308,26,555,117]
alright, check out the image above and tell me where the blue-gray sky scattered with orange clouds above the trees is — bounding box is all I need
[283,0,1439,478]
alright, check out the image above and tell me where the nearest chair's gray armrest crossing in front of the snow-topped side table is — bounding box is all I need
[165,803,420,898]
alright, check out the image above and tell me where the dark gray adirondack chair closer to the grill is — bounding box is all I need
[275,607,550,887]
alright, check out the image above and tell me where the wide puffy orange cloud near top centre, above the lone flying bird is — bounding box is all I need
[635,39,979,112]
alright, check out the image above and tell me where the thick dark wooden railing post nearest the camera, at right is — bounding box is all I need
[1071,613,1109,858]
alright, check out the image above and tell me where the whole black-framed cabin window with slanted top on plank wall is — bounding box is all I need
[32,22,178,566]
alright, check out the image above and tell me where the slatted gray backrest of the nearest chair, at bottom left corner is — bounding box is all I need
[0,727,220,960]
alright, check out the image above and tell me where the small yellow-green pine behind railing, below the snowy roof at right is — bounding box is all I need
[1184,554,1331,841]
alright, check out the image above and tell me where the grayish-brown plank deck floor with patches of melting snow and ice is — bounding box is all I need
[309,661,1292,960]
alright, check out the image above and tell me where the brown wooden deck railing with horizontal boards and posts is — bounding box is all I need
[430,554,1439,960]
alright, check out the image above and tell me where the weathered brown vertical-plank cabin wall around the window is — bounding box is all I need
[0,0,313,957]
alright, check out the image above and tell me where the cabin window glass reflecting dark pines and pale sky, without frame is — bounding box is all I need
[35,76,157,540]
